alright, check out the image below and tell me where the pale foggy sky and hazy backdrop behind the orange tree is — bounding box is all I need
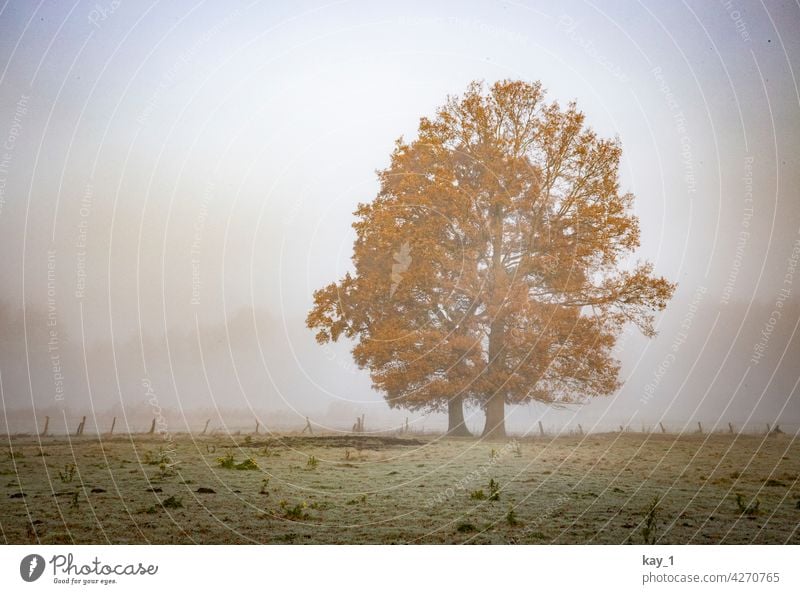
[0,0,800,433]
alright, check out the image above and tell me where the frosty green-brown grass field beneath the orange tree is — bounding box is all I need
[0,433,800,544]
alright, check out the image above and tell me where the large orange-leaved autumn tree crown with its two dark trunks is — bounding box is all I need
[307,81,675,437]
